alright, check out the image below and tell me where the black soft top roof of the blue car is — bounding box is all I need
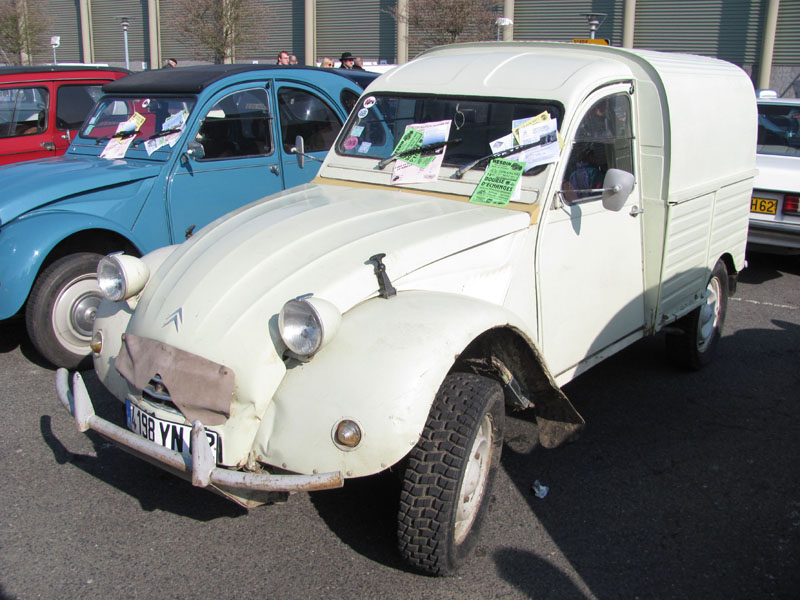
[103,64,378,94]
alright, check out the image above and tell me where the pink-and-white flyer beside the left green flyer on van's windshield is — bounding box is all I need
[391,119,452,184]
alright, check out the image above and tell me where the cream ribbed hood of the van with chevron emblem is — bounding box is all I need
[129,184,530,366]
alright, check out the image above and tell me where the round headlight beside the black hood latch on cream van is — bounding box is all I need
[278,294,342,358]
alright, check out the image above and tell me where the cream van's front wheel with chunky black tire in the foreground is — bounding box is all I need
[397,373,505,575]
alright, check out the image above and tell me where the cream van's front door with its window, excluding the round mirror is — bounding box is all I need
[536,84,645,383]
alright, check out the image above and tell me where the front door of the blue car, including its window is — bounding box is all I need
[167,83,283,243]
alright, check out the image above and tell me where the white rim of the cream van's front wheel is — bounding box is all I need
[455,413,492,544]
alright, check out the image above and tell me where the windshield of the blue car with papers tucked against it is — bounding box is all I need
[80,96,196,146]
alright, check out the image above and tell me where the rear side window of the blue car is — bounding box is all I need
[278,86,342,152]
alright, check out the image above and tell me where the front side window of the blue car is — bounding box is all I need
[195,89,272,160]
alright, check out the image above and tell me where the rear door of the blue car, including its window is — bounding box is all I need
[276,81,345,188]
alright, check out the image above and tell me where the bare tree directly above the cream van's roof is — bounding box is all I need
[387,0,502,48]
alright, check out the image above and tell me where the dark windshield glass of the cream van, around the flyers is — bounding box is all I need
[336,93,563,170]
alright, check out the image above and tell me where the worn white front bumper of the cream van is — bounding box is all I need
[56,369,344,496]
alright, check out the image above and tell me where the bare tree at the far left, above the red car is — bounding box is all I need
[0,0,50,65]
